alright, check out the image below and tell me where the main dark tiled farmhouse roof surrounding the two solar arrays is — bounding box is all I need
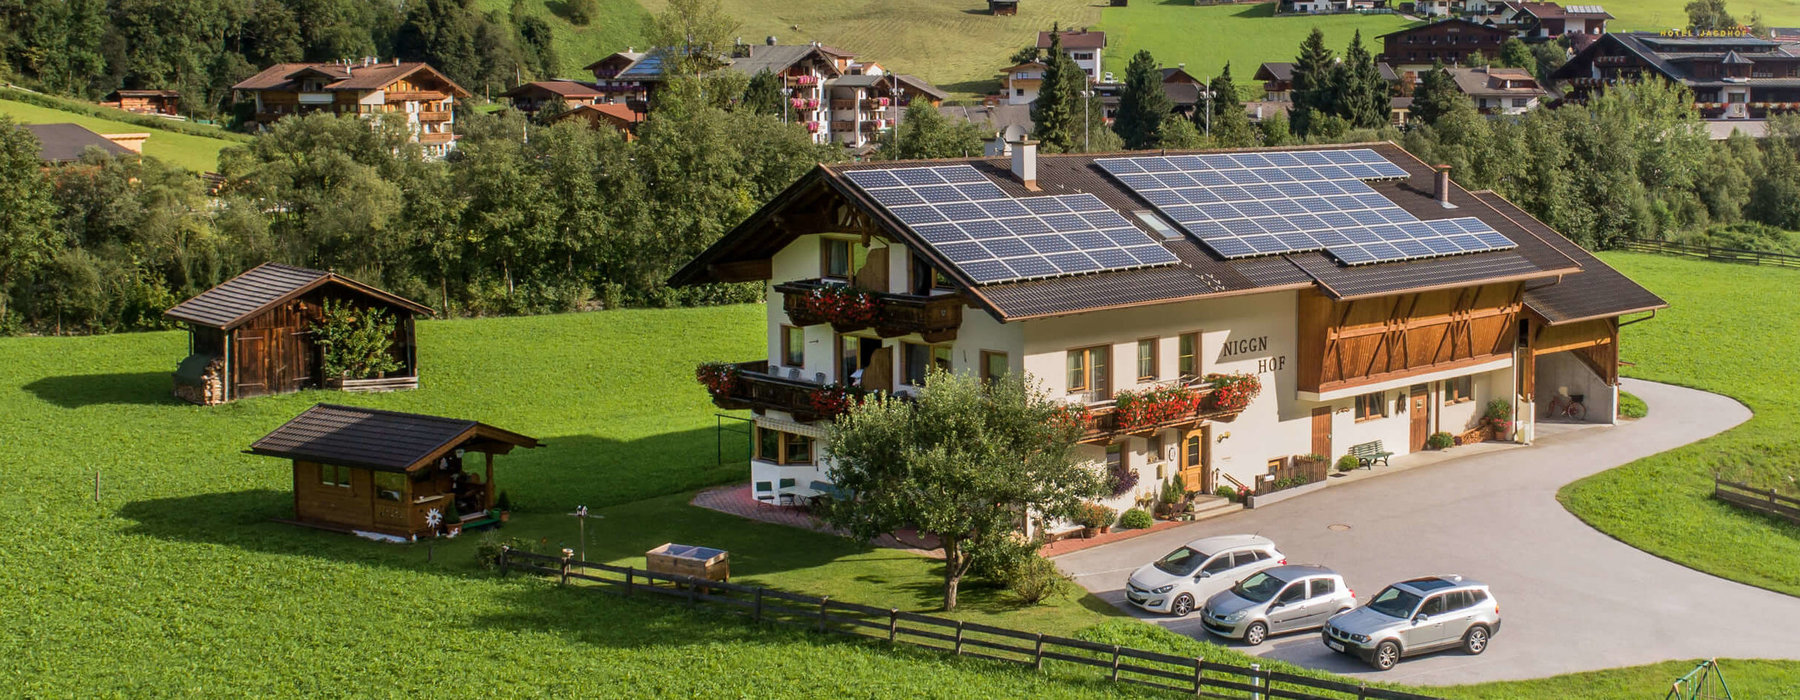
[673,144,1616,320]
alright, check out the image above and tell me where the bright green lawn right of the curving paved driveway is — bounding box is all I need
[1559,254,1800,596]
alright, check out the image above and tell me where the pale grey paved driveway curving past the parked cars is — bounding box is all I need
[1057,380,1800,686]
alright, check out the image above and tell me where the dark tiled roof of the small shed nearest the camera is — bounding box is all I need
[250,403,538,471]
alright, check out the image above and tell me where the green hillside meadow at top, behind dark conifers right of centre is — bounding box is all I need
[1100,0,1411,92]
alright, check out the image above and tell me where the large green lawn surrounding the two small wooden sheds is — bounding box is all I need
[0,296,1800,698]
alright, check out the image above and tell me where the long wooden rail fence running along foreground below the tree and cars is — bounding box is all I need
[499,547,1431,700]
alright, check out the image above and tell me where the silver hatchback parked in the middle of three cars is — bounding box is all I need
[1201,565,1355,646]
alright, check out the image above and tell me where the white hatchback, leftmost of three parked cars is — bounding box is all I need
[1125,534,1287,615]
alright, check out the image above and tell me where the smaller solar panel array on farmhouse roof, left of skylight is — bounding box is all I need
[844,166,1179,284]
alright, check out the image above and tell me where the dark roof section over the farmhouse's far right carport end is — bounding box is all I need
[1474,191,1669,324]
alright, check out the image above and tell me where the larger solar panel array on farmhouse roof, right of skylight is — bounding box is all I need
[1094,148,1516,265]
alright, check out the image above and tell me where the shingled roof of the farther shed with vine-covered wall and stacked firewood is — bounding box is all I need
[162,263,432,329]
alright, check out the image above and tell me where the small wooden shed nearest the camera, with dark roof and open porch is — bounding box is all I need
[247,403,542,540]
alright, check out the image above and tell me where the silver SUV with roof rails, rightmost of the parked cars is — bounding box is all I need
[1323,576,1499,671]
